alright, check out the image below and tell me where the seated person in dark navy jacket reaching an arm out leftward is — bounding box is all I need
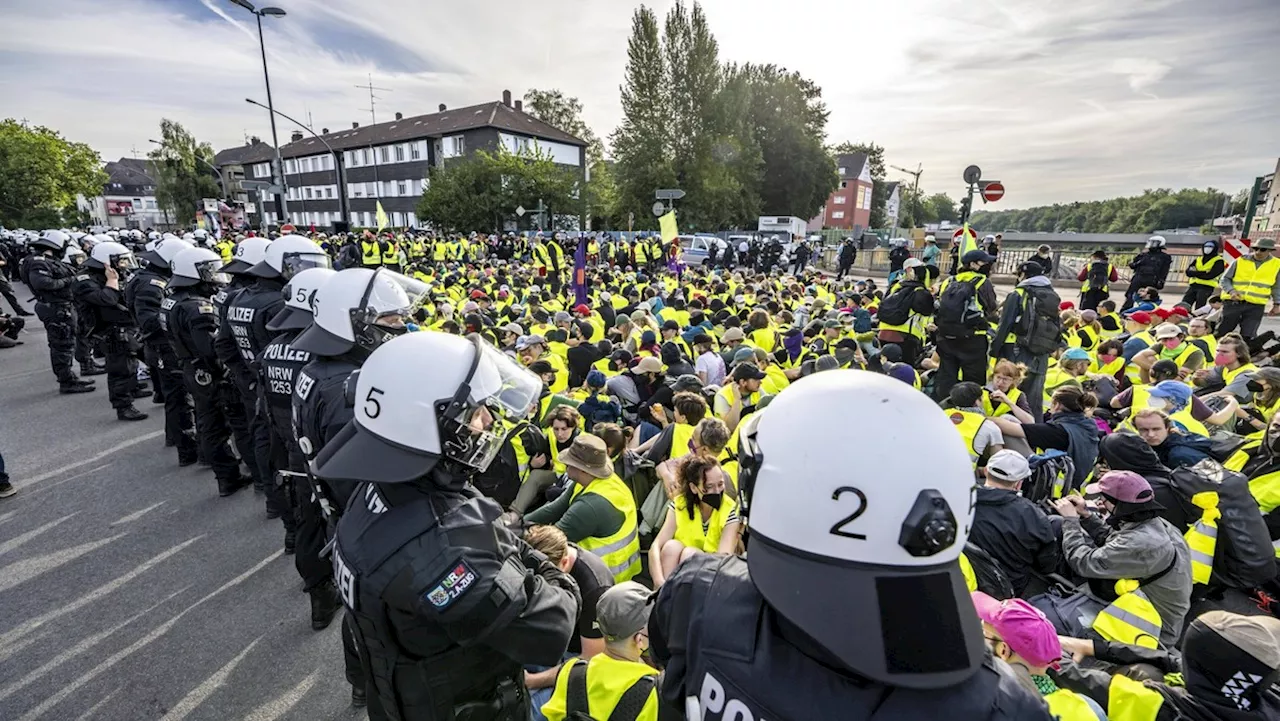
[991,385,1098,488]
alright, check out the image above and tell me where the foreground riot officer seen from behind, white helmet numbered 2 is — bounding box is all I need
[649,370,1050,721]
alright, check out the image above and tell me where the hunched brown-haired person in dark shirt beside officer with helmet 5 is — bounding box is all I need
[525,526,613,716]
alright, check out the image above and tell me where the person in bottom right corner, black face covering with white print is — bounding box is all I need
[1048,611,1280,721]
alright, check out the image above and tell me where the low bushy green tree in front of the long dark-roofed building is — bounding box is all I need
[417,149,581,232]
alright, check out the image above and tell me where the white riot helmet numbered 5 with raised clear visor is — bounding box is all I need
[316,330,545,483]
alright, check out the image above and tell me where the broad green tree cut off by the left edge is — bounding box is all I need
[0,118,106,228]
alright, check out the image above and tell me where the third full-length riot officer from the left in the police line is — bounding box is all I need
[132,238,198,466]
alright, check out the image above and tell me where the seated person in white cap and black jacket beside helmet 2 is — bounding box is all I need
[969,450,1059,595]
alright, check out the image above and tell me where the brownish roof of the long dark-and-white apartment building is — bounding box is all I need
[215,101,586,165]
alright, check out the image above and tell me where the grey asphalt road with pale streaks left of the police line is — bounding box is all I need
[0,284,365,721]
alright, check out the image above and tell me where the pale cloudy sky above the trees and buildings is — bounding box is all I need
[0,0,1280,209]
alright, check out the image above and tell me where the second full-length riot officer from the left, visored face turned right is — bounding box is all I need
[72,242,150,420]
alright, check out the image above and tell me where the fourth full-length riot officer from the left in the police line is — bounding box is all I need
[161,247,252,497]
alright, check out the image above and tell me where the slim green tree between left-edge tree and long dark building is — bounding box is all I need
[147,118,223,224]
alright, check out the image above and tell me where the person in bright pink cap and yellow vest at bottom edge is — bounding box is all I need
[970,590,1106,721]
